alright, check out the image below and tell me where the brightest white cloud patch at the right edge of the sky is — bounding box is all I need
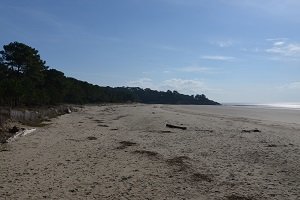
[266,41,300,57]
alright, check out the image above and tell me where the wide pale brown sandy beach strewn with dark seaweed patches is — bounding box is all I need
[0,104,300,200]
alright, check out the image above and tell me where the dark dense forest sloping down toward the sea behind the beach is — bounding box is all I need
[0,42,218,107]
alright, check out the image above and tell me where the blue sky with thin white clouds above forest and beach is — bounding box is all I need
[0,0,300,103]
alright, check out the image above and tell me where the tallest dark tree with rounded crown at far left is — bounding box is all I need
[0,42,47,106]
